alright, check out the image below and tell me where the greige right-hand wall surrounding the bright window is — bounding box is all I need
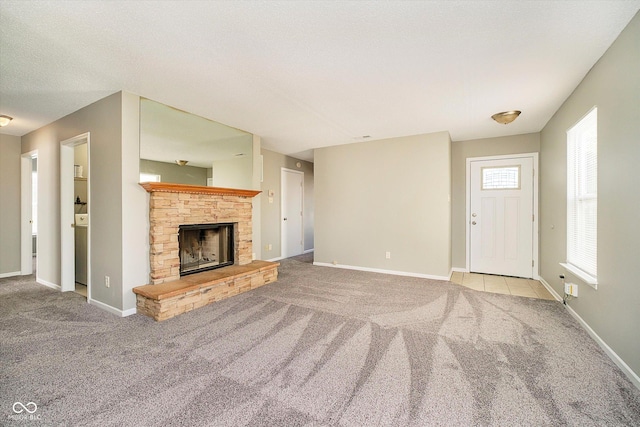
[540,10,640,375]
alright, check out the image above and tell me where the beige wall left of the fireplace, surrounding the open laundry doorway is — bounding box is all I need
[22,92,123,309]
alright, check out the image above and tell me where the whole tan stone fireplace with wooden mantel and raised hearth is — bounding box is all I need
[133,182,280,321]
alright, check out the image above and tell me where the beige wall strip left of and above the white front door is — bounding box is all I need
[451,133,540,269]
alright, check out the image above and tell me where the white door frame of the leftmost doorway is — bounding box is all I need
[20,150,40,275]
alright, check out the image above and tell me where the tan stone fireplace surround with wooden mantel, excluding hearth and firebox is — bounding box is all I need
[140,182,260,285]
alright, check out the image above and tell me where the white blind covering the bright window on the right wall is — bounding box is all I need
[567,108,598,280]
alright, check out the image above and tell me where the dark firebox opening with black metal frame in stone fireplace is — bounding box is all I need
[178,223,234,276]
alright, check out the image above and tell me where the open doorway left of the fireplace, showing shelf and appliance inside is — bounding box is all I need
[60,133,91,301]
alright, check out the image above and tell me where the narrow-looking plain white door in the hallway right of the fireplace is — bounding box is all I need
[281,169,304,258]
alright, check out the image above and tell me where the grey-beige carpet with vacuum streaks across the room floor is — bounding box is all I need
[0,255,640,426]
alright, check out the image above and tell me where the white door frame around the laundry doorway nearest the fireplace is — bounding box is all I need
[60,132,92,301]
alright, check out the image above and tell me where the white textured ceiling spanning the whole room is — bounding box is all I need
[0,0,640,159]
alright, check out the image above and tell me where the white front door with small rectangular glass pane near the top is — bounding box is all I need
[468,157,535,278]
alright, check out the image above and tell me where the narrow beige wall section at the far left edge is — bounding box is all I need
[0,134,21,277]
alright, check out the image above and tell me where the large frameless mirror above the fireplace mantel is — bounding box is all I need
[140,98,253,189]
